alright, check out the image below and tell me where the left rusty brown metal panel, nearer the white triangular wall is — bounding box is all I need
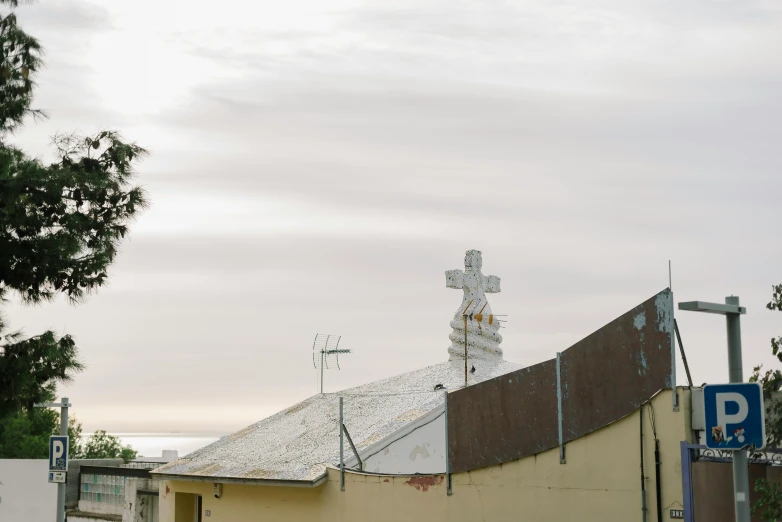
[448,360,557,473]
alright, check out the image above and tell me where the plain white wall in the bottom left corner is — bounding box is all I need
[0,459,57,522]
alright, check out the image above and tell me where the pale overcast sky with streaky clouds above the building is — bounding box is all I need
[1,0,782,432]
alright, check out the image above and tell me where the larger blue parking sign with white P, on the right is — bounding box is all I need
[703,382,766,450]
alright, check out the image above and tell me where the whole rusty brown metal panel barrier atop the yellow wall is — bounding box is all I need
[447,289,673,473]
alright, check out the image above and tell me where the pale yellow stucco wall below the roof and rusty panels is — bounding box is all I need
[160,389,691,522]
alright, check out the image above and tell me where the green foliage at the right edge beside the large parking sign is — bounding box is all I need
[749,285,782,521]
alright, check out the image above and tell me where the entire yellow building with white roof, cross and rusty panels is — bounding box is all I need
[152,250,693,522]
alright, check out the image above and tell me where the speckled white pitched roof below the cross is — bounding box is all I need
[153,357,521,482]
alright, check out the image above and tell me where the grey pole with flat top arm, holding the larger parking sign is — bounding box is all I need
[679,296,750,522]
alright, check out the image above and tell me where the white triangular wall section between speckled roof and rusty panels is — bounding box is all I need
[364,414,445,474]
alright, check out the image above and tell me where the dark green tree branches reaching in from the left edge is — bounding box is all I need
[0,0,145,418]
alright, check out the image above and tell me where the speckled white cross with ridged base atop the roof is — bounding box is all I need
[445,250,502,359]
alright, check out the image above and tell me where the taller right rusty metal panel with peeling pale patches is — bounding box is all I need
[561,290,673,441]
